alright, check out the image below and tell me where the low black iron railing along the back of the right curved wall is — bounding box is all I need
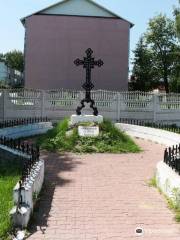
[118,118,180,133]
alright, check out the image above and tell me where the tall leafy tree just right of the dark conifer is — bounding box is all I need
[145,14,177,93]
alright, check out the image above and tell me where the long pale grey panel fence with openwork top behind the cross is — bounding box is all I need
[0,89,180,123]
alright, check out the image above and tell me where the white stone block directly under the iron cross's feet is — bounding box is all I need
[70,115,103,125]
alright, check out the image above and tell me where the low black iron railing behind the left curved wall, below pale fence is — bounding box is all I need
[0,117,49,128]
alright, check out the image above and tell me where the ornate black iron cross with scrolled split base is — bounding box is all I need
[74,48,104,116]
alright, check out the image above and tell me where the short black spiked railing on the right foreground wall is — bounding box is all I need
[164,144,180,175]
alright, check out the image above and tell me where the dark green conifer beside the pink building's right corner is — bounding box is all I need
[130,37,158,91]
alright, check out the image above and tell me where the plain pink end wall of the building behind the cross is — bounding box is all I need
[25,15,130,90]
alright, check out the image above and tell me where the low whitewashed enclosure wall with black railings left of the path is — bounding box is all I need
[0,118,52,231]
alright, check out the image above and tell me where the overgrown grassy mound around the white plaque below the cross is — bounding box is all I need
[37,119,141,153]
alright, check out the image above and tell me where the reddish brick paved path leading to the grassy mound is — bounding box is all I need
[28,140,180,240]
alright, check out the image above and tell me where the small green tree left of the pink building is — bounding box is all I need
[4,50,24,72]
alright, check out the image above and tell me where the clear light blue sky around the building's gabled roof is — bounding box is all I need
[0,0,178,68]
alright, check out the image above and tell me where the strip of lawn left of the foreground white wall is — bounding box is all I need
[0,152,21,240]
